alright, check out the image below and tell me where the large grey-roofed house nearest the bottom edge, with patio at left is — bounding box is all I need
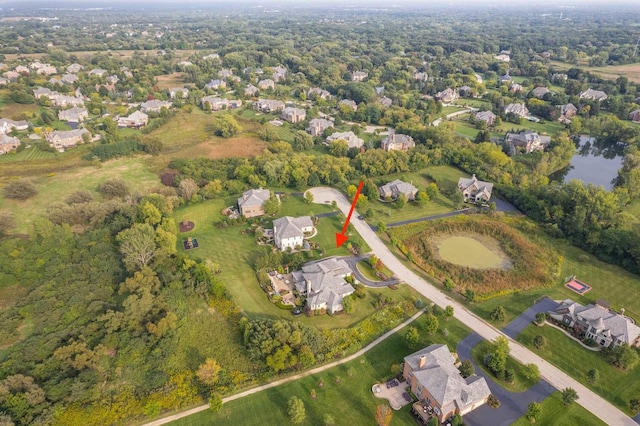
[402,344,491,424]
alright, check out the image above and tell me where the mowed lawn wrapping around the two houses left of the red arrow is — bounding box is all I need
[174,197,408,328]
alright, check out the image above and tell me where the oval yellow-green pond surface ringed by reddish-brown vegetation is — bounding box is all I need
[432,234,511,269]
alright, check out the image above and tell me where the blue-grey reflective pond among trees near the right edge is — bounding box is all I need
[550,136,626,190]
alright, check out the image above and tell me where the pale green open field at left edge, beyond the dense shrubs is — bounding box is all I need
[0,158,160,233]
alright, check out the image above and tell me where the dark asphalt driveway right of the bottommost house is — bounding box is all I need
[456,333,555,426]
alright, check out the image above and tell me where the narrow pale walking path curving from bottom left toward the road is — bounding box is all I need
[144,309,424,426]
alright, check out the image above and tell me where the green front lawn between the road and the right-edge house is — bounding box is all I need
[518,325,640,415]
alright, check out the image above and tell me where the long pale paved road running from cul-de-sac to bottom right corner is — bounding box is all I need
[310,188,638,426]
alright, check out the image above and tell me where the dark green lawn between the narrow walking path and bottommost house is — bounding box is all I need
[170,308,469,426]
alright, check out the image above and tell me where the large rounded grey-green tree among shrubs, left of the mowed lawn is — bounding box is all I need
[116,223,158,270]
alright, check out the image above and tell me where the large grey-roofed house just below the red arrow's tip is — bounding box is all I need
[292,258,355,314]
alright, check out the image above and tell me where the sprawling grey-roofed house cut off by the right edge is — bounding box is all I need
[549,299,640,347]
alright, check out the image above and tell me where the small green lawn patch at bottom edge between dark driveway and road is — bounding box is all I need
[512,391,606,426]
